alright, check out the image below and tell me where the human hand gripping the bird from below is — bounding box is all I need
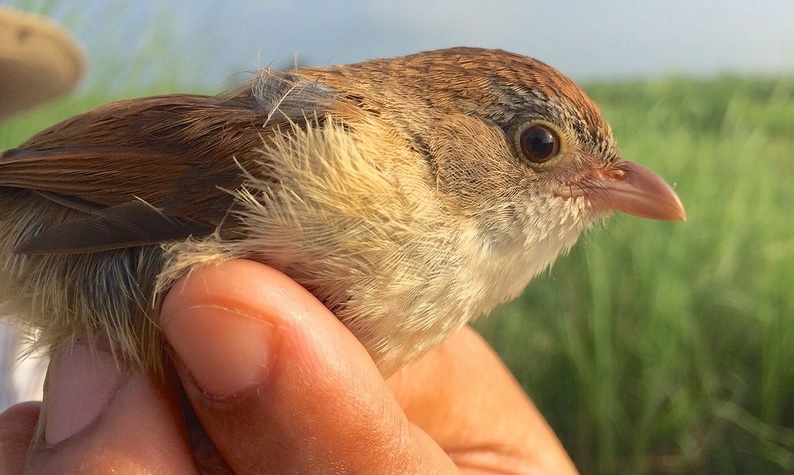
[0,260,575,474]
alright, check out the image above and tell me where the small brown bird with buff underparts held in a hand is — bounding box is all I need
[0,48,684,375]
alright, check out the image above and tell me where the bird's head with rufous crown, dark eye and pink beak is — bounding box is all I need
[350,48,685,247]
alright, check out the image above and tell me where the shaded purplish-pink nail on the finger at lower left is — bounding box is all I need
[44,340,123,444]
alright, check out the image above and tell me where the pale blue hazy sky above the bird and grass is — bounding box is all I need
[7,0,794,92]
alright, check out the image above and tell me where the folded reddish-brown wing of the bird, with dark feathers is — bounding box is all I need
[0,72,333,252]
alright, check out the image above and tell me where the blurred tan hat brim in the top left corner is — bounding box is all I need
[0,7,85,119]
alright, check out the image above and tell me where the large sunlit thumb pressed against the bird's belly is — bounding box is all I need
[161,260,455,473]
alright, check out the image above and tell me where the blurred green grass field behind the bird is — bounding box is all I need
[0,0,794,474]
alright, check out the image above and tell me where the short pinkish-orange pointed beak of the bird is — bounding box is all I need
[568,160,686,221]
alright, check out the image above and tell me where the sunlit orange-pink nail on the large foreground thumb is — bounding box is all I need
[161,305,275,400]
